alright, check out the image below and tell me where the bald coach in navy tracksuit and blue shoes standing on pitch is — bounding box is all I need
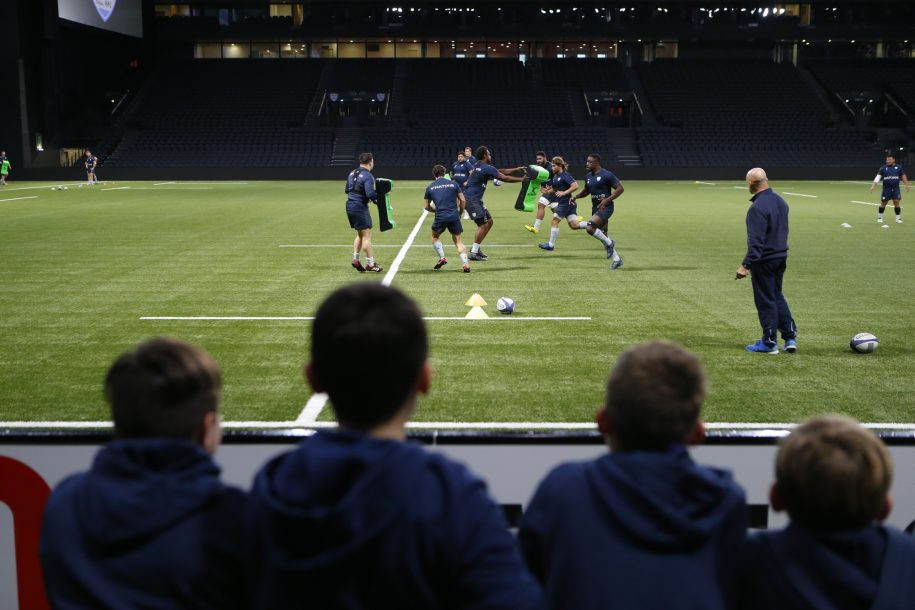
[735,167,797,354]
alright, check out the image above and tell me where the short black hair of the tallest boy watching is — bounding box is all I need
[311,283,429,431]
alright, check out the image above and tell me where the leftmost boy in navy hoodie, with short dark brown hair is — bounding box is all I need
[40,339,245,610]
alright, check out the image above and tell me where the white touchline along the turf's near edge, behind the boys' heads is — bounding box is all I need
[0,420,915,431]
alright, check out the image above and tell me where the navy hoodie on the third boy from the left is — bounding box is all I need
[519,445,747,610]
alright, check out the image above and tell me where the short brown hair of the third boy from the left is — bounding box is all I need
[605,341,706,451]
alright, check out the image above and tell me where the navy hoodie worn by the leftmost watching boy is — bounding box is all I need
[40,439,246,610]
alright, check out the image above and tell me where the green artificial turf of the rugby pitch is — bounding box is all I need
[0,172,915,423]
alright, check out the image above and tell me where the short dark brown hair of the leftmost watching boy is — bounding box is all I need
[105,338,222,440]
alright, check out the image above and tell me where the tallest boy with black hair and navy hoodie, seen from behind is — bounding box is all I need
[248,283,543,610]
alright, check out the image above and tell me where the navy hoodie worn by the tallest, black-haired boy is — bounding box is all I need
[249,431,543,610]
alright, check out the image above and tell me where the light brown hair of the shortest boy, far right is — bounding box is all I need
[775,415,893,530]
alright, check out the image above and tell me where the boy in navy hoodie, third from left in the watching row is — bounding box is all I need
[519,341,747,610]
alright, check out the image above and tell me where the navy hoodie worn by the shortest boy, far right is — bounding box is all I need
[740,524,915,610]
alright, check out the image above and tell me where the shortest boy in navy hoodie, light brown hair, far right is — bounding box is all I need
[740,416,915,610]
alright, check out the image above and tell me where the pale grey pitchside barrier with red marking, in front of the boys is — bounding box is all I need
[0,427,915,610]
